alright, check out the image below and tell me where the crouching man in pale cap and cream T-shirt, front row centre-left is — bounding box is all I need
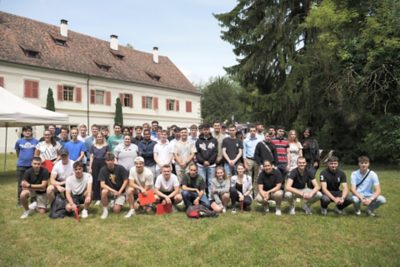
[125,157,154,218]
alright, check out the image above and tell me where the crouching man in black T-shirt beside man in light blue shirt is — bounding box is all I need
[320,156,353,215]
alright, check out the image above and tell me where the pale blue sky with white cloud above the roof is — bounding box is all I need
[0,0,236,84]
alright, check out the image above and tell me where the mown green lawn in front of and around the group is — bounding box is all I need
[0,154,400,266]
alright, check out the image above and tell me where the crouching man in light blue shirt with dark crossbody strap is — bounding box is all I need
[351,156,386,216]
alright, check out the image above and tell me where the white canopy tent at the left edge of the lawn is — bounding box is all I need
[0,86,68,170]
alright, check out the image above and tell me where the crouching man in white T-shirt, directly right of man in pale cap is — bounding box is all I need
[154,164,182,205]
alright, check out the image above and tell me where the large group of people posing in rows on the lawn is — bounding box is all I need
[15,121,386,219]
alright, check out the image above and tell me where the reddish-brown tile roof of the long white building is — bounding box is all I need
[0,12,199,94]
